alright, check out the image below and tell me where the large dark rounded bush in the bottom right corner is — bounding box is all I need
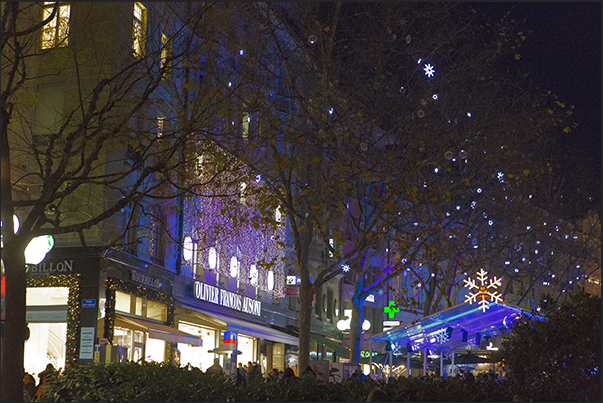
[499,293,601,402]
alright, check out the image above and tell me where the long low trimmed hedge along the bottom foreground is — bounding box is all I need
[34,362,513,402]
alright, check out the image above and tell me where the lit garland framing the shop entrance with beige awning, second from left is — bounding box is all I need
[103,277,176,359]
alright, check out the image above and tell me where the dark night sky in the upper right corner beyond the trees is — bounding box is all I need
[470,2,601,211]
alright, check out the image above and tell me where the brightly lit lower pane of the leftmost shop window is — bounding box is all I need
[23,322,67,383]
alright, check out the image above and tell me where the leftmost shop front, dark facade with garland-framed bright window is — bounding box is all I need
[24,248,100,375]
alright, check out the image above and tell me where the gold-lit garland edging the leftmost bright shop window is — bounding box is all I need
[27,273,81,363]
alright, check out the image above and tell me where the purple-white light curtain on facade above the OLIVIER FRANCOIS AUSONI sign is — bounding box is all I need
[183,150,286,298]
